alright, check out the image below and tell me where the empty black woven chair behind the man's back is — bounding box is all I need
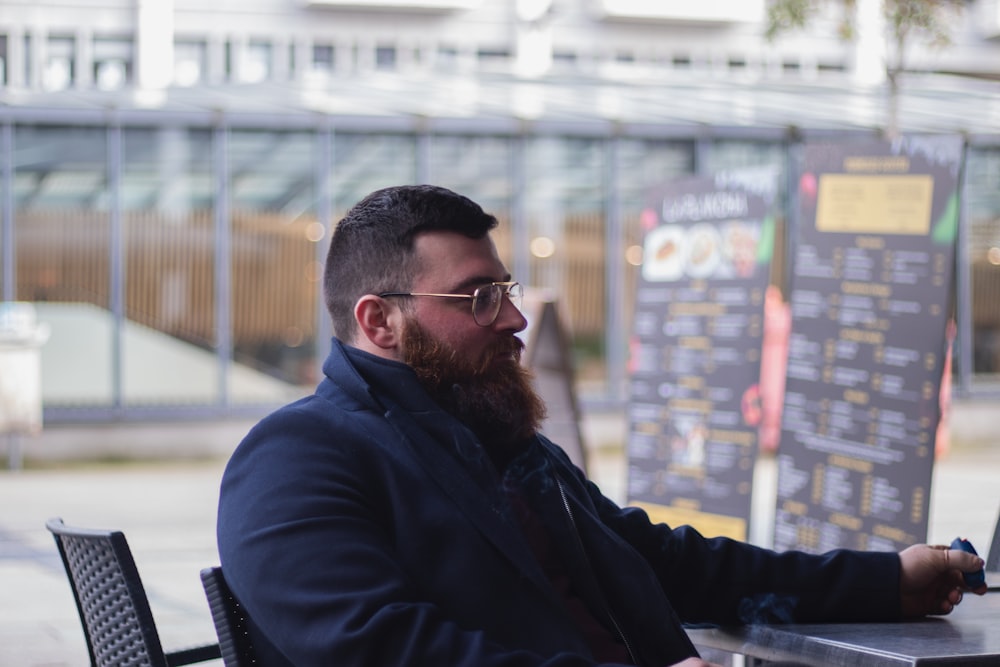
[45,518,222,667]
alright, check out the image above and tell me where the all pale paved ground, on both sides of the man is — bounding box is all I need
[0,436,1000,667]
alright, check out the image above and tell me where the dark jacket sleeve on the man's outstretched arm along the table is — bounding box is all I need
[556,446,901,624]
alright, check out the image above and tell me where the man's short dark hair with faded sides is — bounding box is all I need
[323,185,497,342]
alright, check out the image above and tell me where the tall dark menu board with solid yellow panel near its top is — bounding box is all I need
[774,137,962,553]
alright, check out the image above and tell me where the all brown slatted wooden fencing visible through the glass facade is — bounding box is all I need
[9,210,1000,366]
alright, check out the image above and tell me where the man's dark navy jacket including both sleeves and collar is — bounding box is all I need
[218,341,899,667]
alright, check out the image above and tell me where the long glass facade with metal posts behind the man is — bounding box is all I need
[0,118,1000,421]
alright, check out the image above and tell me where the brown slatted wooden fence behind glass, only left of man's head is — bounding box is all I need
[16,211,321,346]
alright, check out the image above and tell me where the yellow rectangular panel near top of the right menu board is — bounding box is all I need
[816,174,934,234]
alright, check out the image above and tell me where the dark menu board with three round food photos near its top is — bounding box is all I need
[628,169,777,540]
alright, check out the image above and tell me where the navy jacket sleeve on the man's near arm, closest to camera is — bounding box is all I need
[218,409,628,667]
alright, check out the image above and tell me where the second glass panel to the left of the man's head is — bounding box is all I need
[121,127,221,405]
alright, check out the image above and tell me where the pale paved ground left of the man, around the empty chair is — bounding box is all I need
[0,461,223,667]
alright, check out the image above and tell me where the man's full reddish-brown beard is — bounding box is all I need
[403,319,545,447]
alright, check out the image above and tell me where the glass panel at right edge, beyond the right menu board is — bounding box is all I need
[965,148,1000,383]
